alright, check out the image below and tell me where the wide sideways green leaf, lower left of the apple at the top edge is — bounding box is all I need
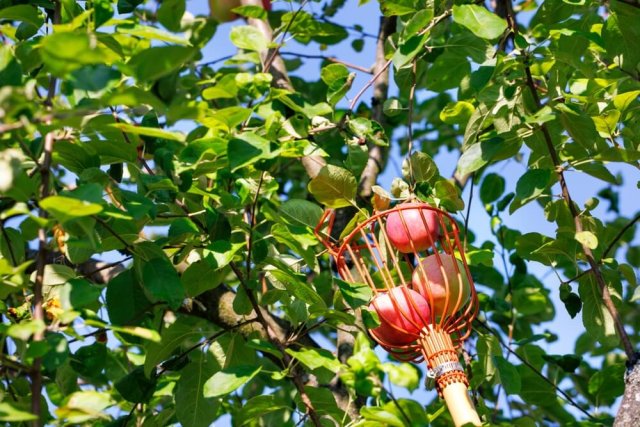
[127,46,197,81]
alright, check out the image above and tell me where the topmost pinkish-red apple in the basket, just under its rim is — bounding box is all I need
[386,203,440,253]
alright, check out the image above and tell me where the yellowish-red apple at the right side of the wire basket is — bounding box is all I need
[411,254,471,316]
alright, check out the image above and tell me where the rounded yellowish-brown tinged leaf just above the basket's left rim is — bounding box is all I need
[309,165,358,208]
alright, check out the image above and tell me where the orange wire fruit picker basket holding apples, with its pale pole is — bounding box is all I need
[315,201,481,426]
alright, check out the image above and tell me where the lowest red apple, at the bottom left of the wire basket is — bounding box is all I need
[369,286,431,345]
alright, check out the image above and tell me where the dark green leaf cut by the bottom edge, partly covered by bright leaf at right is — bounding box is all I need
[175,352,220,427]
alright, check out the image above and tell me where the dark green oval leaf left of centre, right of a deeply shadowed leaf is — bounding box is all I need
[142,258,185,310]
